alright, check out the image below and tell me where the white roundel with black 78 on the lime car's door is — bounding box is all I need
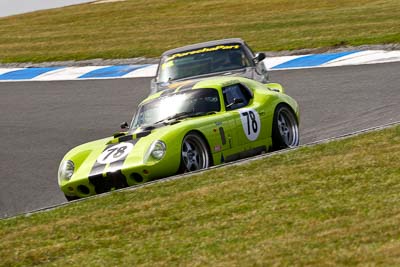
[239,108,261,141]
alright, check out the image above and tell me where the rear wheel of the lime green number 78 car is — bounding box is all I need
[272,104,300,150]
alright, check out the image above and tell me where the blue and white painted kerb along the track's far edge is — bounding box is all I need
[0,50,400,82]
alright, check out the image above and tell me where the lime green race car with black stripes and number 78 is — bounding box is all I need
[58,77,299,200]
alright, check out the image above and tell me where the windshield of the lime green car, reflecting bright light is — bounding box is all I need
[131,88,221,129]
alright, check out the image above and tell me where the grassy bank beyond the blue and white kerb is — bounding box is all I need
[0,0,400,63]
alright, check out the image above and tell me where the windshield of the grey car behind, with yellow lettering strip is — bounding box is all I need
[158,44,250,82]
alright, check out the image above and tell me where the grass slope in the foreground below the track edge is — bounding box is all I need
[0,126,400,266]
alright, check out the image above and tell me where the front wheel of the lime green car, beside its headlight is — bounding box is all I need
[180,132,212,173]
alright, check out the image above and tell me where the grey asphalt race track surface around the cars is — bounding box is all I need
[0,63,400,218]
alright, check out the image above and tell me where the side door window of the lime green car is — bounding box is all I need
[222,83,252,110]
